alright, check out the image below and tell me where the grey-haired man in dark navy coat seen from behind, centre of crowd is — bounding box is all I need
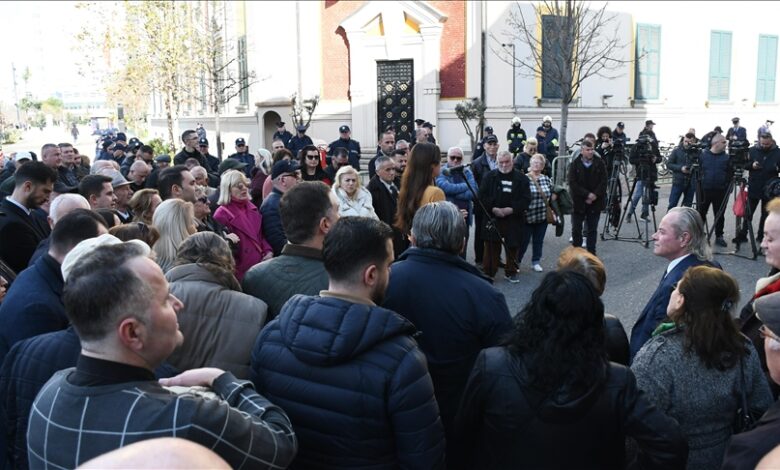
[383,201,512,457]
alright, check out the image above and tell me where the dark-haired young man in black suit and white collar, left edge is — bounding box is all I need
[0,162,59,273]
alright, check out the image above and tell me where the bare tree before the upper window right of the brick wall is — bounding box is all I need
[492,0,633,155]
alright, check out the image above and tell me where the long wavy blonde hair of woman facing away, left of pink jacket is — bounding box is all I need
[152,198,195,272]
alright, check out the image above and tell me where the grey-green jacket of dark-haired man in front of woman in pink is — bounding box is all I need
[241,243,328,322]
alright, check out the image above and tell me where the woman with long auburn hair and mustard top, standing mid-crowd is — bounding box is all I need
[394,143,446,236]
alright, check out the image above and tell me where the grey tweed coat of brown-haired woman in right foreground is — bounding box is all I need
[631,328,772,470]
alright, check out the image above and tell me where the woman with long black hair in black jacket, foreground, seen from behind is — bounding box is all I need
[449,271,685,469]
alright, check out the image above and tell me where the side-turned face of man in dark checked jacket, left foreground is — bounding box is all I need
[133,257,184,366]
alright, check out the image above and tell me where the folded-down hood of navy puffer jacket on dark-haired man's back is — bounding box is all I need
[278,295,415,366]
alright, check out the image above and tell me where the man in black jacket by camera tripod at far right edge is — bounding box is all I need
[734,132,780,243]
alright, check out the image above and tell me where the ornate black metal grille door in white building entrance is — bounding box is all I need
[376,60,414,141]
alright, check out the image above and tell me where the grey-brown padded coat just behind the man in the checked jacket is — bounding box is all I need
[165,264,268,379]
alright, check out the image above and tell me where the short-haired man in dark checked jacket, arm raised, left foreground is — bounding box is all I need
[27,243,297,469]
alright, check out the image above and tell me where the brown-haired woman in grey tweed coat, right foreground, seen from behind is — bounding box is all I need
[631,266,772,470]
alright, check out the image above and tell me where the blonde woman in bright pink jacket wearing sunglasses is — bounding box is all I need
[214,170,273,282]
